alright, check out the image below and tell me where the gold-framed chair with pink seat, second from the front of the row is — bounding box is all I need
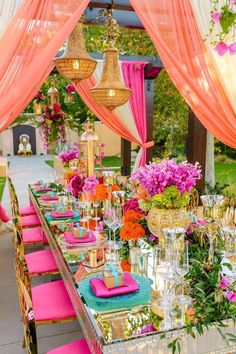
[15,257,77,354]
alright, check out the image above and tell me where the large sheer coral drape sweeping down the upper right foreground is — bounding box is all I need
[130,0,236,148]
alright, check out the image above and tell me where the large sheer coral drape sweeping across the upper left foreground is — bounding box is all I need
[0,0,89,131]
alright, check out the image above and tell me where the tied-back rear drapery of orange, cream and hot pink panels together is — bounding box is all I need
[76,61,153,166]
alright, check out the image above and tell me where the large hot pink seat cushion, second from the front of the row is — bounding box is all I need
[32,280,76,321]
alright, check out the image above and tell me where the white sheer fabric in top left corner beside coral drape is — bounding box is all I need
[0,0,22,38]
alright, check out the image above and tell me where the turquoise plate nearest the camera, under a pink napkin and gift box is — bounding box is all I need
[78,273,151,311]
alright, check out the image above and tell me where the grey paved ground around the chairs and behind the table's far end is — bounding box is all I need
[0,156,82,354]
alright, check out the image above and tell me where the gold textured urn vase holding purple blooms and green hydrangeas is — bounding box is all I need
[147,207,191,239]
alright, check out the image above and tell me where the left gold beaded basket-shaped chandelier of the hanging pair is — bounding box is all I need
[54,22,97,84]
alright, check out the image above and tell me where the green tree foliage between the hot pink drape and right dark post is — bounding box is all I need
[154,70,188,157]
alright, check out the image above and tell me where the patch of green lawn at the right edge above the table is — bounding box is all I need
[215,162,236,195]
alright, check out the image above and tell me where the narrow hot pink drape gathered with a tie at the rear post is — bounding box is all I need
[121,61,147,166]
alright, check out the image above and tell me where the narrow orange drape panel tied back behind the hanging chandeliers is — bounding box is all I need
[76,76,139,144]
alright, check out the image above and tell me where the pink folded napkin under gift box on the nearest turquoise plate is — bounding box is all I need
[89,272,139,297]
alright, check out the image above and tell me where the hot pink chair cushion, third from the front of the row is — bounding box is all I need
[25,249,58,275]
